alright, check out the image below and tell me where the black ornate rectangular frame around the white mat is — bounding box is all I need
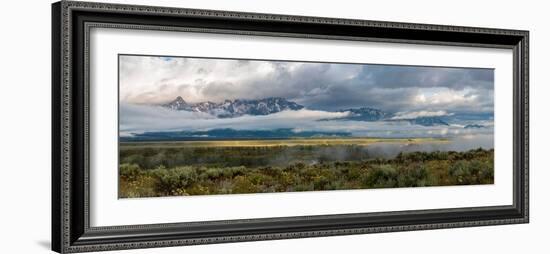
[52,1,529,253]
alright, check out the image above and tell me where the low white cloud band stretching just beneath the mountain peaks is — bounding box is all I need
[120,103,492,137]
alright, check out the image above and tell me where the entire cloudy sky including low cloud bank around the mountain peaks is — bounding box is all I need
[119,55,493,137]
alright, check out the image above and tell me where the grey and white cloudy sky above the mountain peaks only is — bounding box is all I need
[119,55,494,114]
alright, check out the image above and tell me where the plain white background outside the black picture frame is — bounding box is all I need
[0,0,550,254]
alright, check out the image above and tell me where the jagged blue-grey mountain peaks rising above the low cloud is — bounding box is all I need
[162,96,458,126]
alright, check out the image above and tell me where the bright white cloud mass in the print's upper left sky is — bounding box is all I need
[120,56,361,104]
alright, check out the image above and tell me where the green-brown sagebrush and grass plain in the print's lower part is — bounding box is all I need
[119,145,494,198]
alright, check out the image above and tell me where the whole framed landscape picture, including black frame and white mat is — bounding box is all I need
[52,1,529,253]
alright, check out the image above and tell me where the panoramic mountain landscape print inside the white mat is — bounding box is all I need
[118,55,494,198]
